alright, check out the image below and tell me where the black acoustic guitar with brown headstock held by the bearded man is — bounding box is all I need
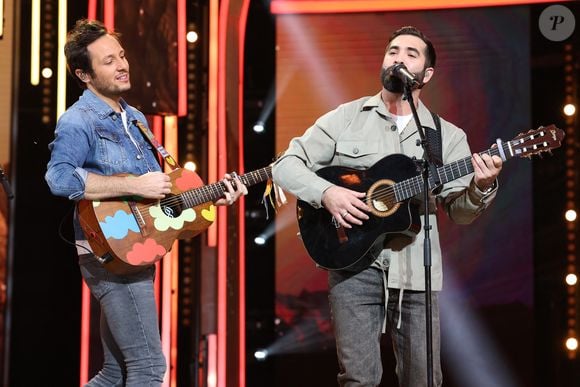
[296,125,564,270]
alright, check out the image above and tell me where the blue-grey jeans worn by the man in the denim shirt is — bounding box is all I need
[79,255,166,387]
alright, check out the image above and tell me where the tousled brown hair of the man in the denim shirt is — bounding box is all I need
[64,19,120,88]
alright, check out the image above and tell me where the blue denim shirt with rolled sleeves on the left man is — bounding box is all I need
[45,89,161,200]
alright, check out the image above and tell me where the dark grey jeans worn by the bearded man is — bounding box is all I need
[328,267,442,387]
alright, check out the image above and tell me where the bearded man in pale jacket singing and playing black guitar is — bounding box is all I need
[273,26,502,387]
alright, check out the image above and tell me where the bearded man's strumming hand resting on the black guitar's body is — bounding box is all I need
[322,185,370,228]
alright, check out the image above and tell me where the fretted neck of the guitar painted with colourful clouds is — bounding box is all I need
[179,166,272,208]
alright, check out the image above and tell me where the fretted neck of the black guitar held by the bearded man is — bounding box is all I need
[394,142,513,202]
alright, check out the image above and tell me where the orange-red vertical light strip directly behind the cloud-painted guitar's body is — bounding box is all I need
[161,116,179,387]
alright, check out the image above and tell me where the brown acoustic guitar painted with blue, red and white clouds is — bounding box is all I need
[78,166,272,274]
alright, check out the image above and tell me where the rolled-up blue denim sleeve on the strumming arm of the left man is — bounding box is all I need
[45,115,91,200]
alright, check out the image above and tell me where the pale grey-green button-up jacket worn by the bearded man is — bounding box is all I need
[272,94,497,291]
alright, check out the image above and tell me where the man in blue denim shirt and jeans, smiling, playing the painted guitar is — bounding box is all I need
[46,20,247,387]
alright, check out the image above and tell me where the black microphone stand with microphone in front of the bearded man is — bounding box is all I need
[403,81,440,387]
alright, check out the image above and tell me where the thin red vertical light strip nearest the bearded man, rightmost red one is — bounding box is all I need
[238,0,250,387]
